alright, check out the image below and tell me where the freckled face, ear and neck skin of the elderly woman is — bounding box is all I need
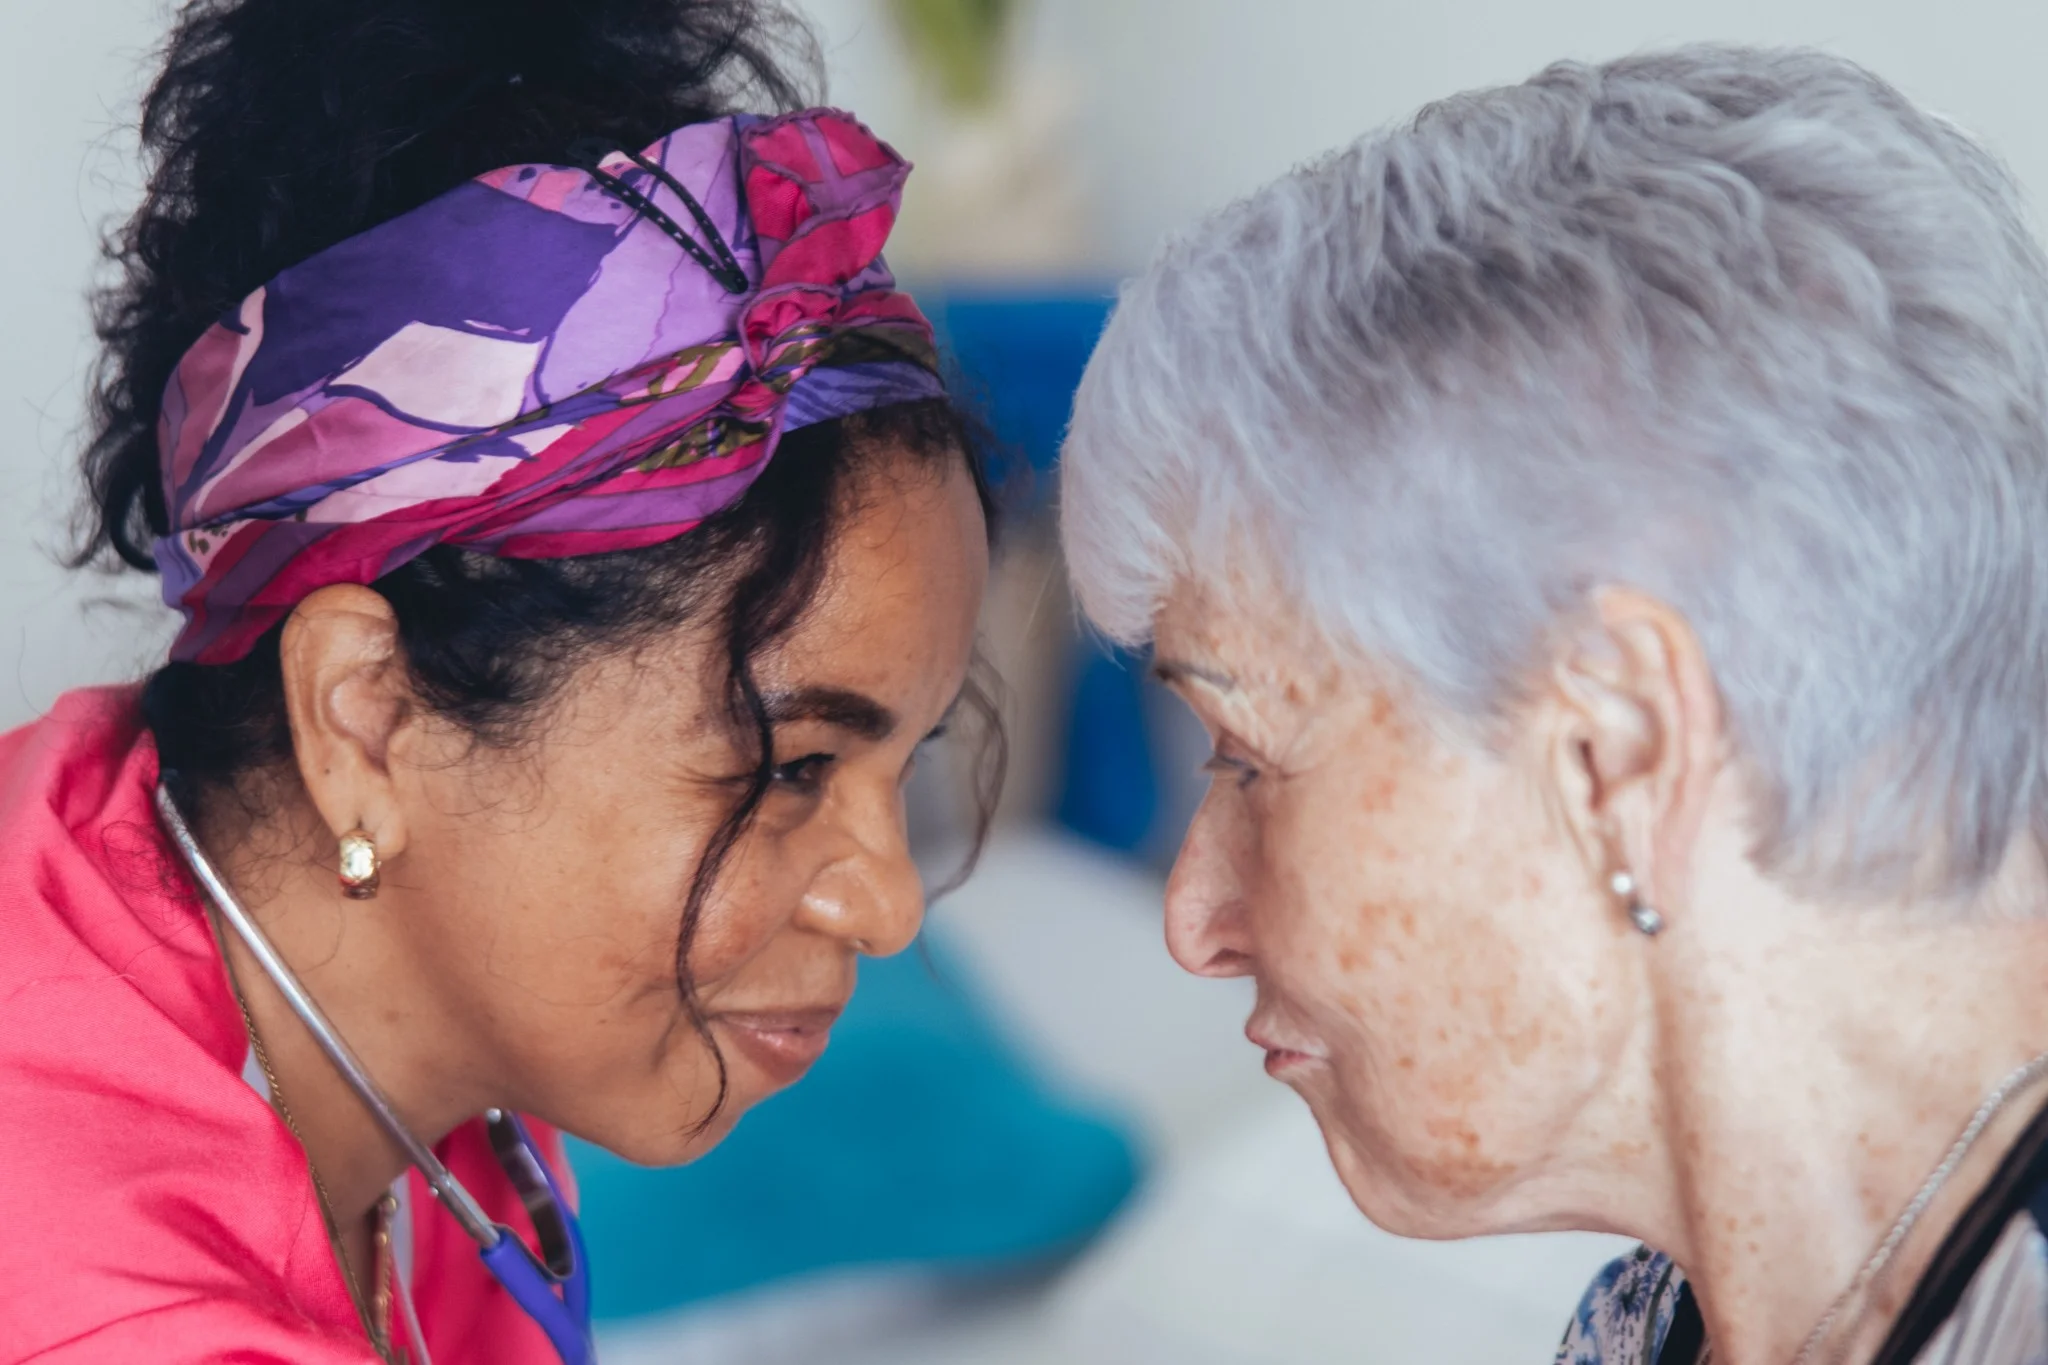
[1153,567,2048,1365]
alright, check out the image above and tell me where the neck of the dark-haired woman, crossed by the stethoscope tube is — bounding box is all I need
[207,794,489,1230]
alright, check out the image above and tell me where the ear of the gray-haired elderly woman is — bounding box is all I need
[1542,587,1722,898]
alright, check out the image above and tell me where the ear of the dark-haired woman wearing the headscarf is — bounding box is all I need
[279,583,412,860]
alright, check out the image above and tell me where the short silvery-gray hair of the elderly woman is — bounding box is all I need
[1063,47,2048,892]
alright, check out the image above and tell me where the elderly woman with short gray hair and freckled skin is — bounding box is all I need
[1065,49,2048,1365]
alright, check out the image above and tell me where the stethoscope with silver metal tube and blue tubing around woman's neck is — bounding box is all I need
[156,782,596,1365]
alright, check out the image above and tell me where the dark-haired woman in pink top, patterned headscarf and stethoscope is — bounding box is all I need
[0,0,989,1365]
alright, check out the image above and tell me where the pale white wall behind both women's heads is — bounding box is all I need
[0,0,2048,724]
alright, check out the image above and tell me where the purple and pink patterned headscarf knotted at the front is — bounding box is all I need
[154,108,942,663]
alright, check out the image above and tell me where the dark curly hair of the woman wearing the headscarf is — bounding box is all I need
[76,0,1001,1124]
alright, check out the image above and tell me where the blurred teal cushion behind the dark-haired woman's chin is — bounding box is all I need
[569,939,1139,1320]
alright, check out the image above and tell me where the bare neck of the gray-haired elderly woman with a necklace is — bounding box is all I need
[1642,839,2048,1365]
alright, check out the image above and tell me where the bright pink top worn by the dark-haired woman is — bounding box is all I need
[0,688,567,1365]
